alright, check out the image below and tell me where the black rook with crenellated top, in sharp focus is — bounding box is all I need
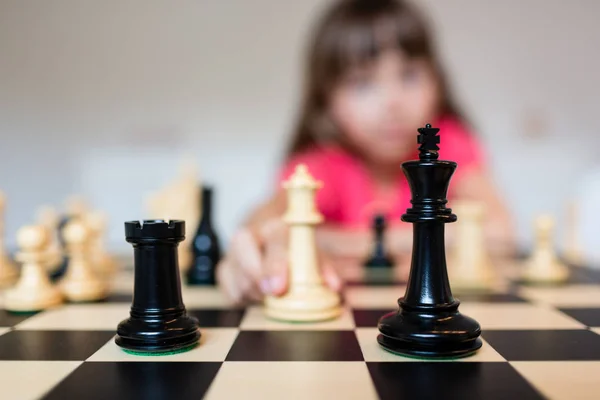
[115,220,200,353]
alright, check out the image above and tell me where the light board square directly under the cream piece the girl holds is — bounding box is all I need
[240,306,354,331]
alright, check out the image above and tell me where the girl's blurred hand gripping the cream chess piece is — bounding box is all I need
[217,218,342,303]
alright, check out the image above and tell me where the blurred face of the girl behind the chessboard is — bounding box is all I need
[329,51,439,164]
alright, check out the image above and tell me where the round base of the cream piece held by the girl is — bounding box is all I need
[265,286,342,322]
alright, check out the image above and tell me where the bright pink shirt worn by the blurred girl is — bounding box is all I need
[279,118,483,229]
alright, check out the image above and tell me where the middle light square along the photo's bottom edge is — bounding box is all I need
[206,362,377,400]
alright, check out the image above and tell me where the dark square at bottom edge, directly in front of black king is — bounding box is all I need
[367,361,543,400]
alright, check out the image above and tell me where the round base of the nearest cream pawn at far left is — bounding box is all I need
[4,287,63,312]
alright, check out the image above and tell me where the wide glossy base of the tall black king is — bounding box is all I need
[377,302,482,358]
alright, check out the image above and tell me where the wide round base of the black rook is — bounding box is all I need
[115,309,201,353]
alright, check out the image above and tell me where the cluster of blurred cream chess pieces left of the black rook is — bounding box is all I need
[0,193,118,312]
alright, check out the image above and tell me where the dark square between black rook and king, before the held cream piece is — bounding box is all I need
[226,331,364,361]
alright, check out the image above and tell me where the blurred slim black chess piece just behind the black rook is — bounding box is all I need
[186,186,221,285]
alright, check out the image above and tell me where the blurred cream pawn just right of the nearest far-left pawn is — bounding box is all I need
[60,219,107,302]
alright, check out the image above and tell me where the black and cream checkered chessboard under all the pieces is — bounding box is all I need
[0,264,600,400]
